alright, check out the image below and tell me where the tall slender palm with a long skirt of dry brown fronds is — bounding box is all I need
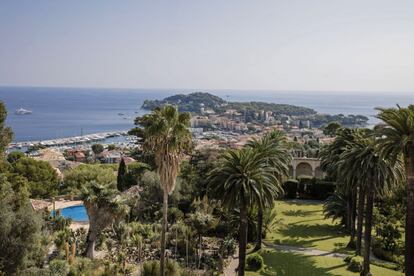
[135,106,192,275]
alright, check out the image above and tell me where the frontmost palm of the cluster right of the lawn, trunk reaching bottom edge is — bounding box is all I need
[339,131,402,276]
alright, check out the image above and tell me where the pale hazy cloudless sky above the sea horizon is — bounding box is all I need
[0,0,414,93]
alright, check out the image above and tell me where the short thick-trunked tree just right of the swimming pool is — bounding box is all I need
[81,182,129,259]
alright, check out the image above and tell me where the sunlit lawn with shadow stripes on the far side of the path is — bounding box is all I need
[266,200,349,253]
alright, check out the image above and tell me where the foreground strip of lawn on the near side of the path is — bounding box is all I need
[246,249,403,276]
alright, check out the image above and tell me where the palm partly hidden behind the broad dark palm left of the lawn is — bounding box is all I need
[247,131,292,251]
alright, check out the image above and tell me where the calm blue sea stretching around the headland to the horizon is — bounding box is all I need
[0,87,414,141]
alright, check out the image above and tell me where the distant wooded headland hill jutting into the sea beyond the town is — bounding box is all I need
[142,92,316,116]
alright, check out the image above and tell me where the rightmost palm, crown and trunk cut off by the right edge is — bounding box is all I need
[377,105,414,276]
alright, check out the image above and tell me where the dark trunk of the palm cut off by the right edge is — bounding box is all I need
[405,155,414,276]
